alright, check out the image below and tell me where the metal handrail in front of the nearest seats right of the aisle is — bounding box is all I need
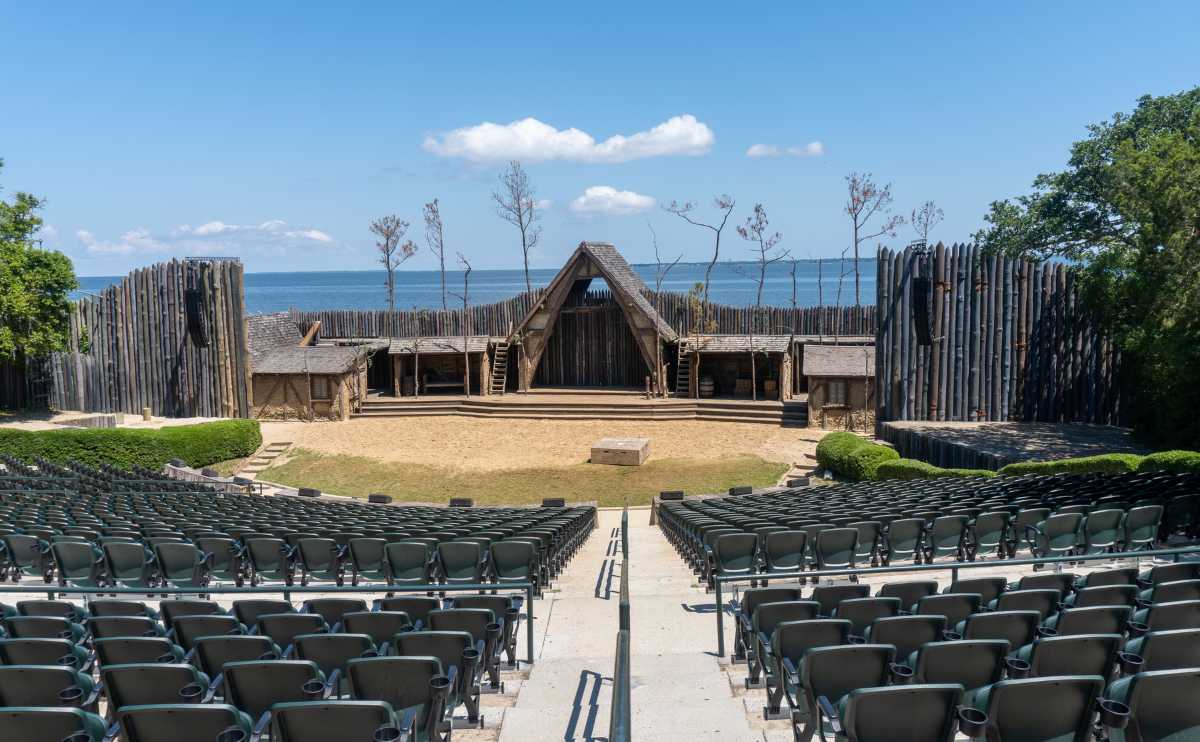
[713,545,1200,657]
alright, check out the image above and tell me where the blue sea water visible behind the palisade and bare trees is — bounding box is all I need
[74,259,875,313]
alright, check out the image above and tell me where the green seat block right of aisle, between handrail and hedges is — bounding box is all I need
[659,473,1200,586]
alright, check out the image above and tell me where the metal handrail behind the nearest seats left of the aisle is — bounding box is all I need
[0,582,534,665]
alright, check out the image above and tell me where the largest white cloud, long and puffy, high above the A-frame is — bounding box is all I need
[422,114,716,163]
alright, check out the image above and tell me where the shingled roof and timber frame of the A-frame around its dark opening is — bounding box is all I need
[509,243,678,391]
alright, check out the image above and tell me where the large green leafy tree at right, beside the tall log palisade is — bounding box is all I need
[976,88,1200,448]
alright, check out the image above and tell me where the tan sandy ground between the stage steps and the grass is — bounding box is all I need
[263,417,822,471]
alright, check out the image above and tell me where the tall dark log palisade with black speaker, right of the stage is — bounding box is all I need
[875,244,1121,425]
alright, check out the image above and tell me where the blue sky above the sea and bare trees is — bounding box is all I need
[0,2,1200,275]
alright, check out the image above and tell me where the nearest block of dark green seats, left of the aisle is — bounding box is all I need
[0,594,522,742]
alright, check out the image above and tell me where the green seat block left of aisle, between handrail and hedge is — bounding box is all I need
[0,453,595,592]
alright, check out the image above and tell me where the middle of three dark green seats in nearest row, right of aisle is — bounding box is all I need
[973,675,1104,742]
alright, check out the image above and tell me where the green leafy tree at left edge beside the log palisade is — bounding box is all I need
[0,160,78,363]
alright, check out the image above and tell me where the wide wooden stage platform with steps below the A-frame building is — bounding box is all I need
[353,388,808,427]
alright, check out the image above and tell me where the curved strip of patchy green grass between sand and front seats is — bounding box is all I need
[260,449,788,507]
